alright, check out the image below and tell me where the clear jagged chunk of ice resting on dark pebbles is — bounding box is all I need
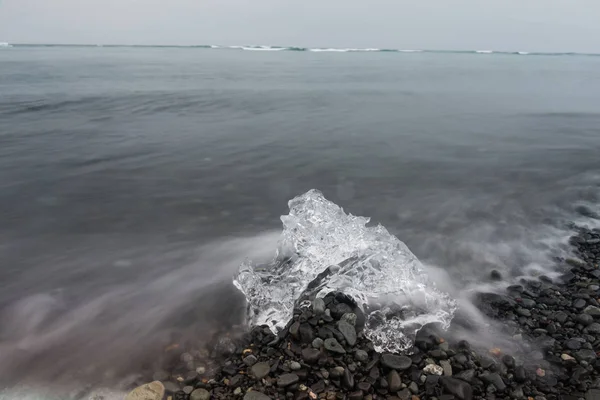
[234,190,456,351]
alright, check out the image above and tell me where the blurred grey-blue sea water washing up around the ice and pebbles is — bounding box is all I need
[0,46,600,398]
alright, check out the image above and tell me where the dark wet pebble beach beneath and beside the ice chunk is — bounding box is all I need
[132,228,600,400]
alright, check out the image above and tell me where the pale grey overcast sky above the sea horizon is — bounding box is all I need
[0,0,600,53]
